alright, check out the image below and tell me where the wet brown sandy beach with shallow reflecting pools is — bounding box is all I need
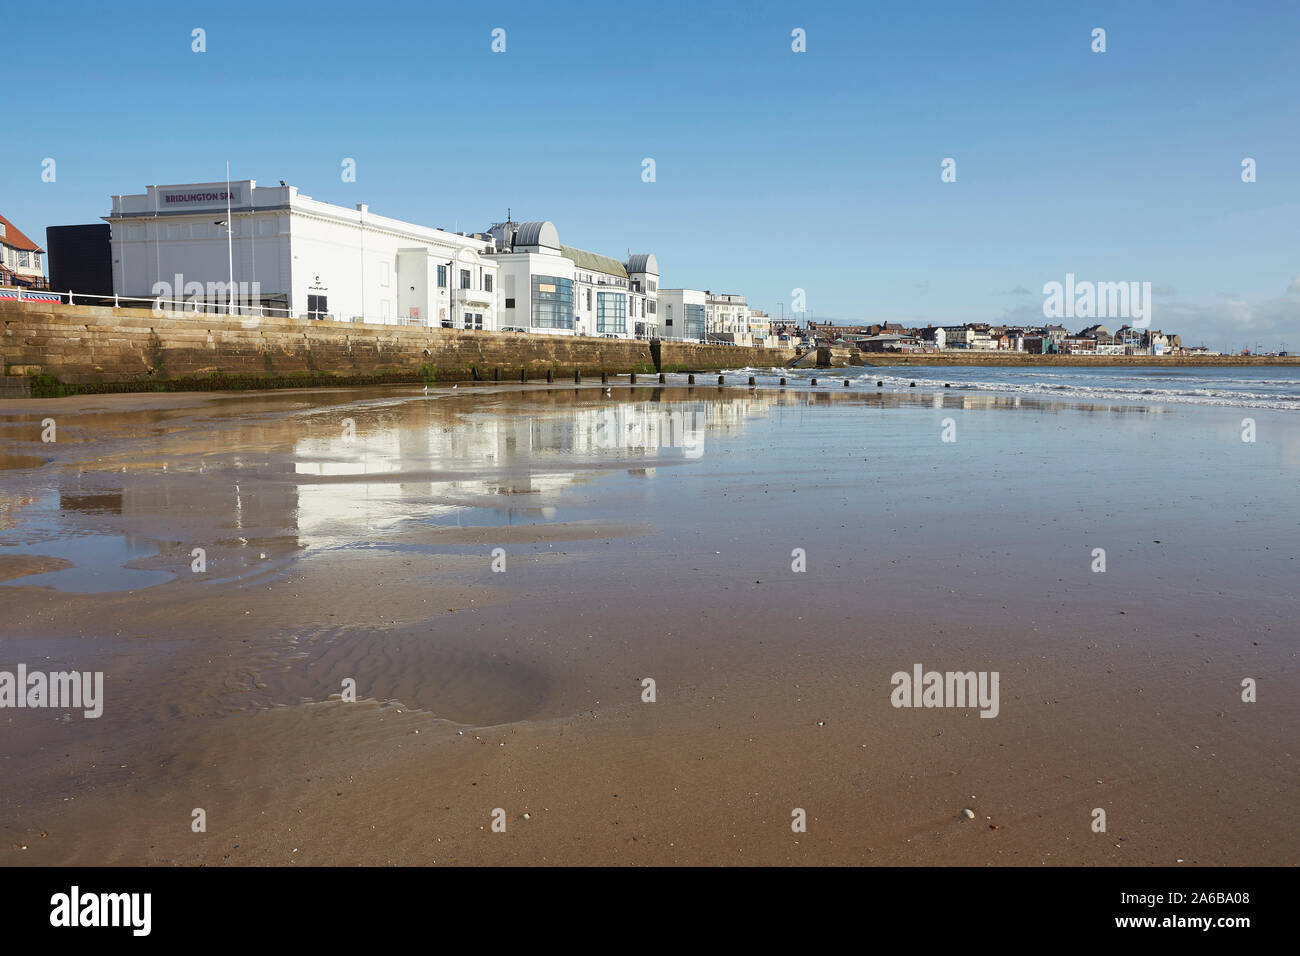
[0,386,1300,866]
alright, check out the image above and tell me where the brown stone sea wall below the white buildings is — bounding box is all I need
[0,300,794,397]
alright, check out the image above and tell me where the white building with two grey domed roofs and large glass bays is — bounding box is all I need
[488,220,659,338]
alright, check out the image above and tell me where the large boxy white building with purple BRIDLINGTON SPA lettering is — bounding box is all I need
[104,179,497,329]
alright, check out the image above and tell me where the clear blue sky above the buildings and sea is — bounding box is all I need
[0,0,1300,349]
